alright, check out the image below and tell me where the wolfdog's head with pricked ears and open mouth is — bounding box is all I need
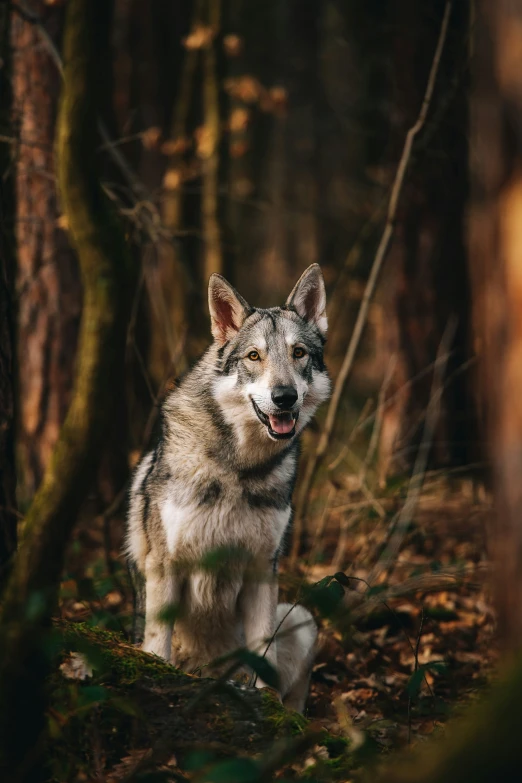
[209,264,330,441]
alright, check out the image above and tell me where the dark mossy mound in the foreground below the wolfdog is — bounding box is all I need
[48,622,353,781]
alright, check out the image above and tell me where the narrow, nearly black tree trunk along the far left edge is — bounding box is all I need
[0,5,17,589]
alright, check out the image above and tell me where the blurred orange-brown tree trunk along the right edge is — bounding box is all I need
[470,0,522,651]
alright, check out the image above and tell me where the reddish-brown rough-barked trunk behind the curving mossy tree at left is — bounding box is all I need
[11,0,81,504]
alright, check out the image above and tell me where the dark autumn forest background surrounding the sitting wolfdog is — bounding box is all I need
[0,0,522,783]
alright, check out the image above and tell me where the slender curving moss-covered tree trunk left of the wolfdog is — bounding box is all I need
[0,0,131,781]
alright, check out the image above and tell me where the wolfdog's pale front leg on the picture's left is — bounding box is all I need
[143,555,180,661]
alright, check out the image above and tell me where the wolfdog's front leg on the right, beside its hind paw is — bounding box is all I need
[240,573,278,688]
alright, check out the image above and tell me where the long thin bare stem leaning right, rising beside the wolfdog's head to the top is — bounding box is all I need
[291,0,453,565]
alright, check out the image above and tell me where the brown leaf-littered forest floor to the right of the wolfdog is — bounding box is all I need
[298,485,498,749]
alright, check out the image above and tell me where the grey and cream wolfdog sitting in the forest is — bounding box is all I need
[126,264,330,711]
